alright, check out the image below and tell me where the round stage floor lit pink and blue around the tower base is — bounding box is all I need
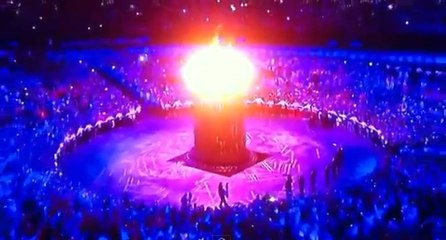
[61,117,381,205]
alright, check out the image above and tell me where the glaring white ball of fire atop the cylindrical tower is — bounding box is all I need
[182,43,255,102]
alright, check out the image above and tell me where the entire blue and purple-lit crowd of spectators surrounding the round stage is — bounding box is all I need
[0,48,446,239]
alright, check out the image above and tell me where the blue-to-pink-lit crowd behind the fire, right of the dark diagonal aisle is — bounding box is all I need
[96,48,446,149]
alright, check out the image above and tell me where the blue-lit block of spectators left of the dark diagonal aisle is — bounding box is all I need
[0,51,137,170]
